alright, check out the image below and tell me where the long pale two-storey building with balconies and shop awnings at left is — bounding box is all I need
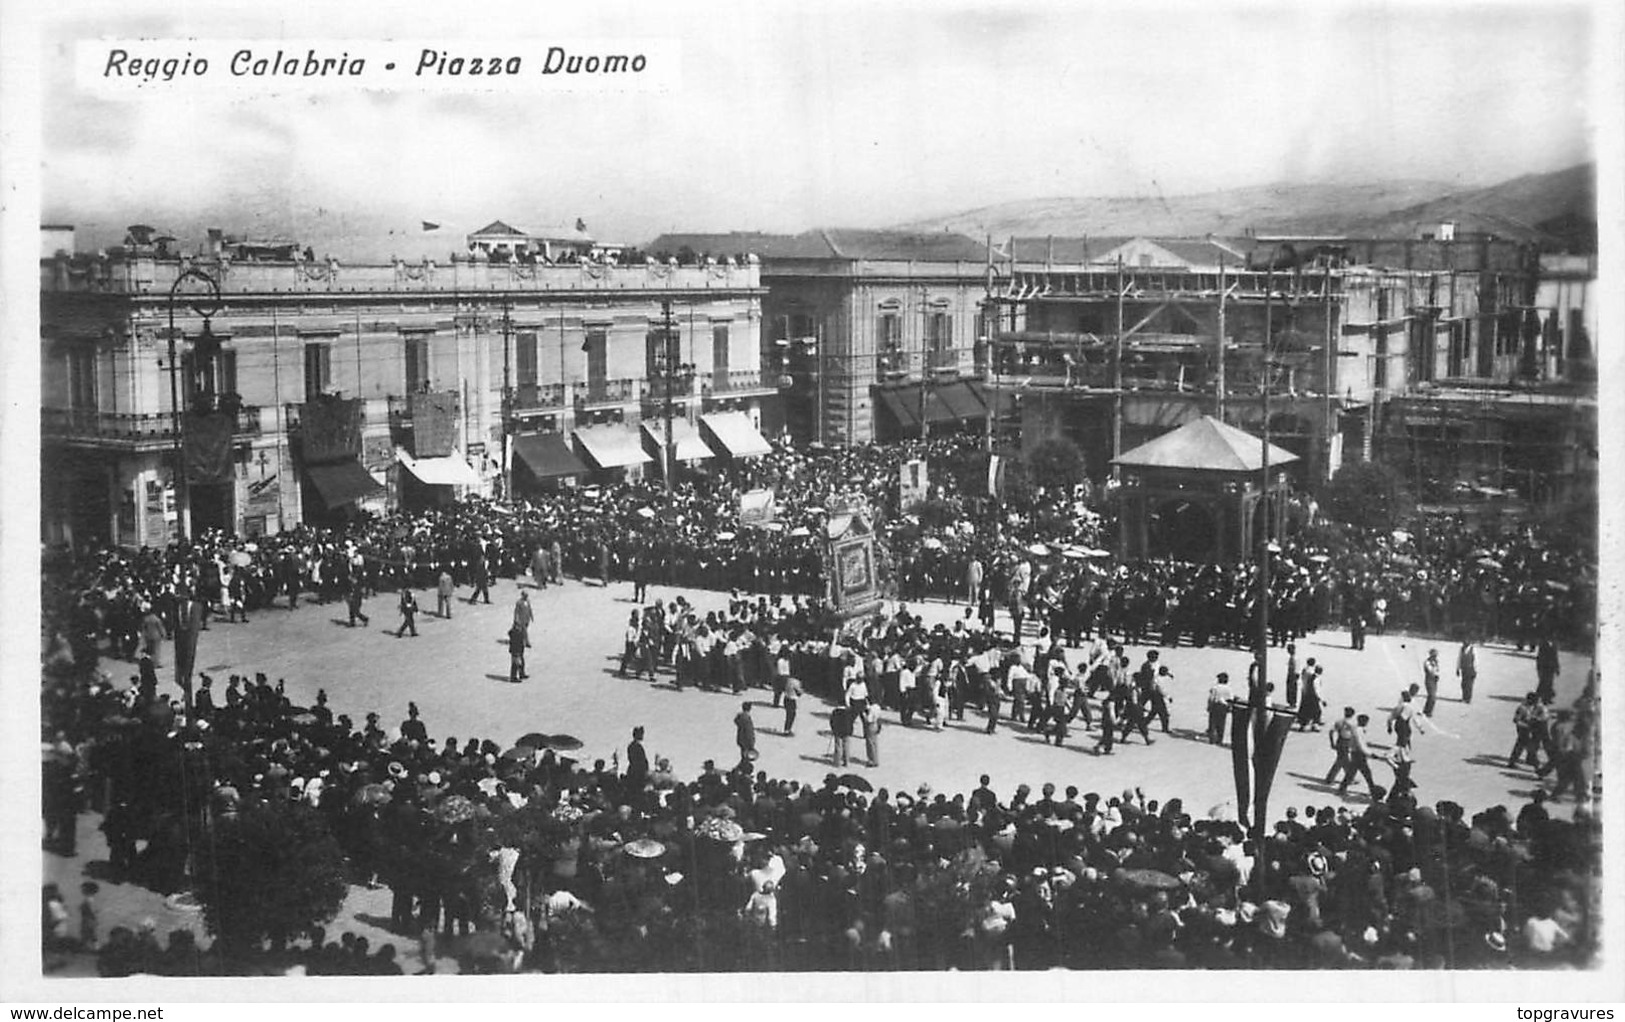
[41,220,777,546]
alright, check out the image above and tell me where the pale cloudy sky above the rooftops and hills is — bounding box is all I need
[31,0,1612,255]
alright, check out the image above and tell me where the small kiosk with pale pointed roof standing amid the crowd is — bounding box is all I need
[1112,416,1298,562]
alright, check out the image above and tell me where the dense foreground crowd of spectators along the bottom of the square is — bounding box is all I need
[34,646,1601,975]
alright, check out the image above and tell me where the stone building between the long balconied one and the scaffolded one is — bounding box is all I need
[648,229,988,445]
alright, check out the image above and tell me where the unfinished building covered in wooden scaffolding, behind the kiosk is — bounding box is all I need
[986,230,1596,497]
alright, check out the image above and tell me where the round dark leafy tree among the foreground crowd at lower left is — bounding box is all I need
[197,803,349,951]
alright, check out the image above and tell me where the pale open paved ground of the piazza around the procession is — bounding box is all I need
[174,580,1589,814]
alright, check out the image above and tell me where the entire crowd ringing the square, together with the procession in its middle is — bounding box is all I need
[44,428,1599,975]
